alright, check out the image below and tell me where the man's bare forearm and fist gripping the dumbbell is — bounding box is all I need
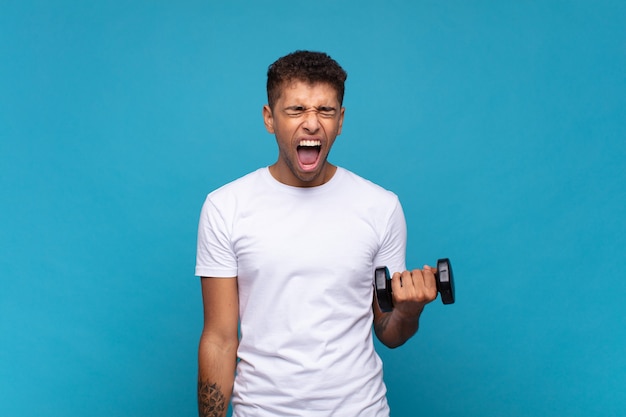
[372,266,437,348]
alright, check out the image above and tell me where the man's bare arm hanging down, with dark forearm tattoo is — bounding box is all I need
[198,277,239,417]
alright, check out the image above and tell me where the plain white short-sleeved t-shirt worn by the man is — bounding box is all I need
[196,168,406,417]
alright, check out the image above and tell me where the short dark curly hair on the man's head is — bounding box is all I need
[267,51,348,108]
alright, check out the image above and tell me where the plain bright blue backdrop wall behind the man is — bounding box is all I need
[0,0,626,417]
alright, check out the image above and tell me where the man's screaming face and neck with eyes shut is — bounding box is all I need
[263,80,344,187]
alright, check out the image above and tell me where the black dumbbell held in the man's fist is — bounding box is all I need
[374,258,454,312]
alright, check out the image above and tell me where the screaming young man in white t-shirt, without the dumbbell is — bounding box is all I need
[196,51,437,417]
